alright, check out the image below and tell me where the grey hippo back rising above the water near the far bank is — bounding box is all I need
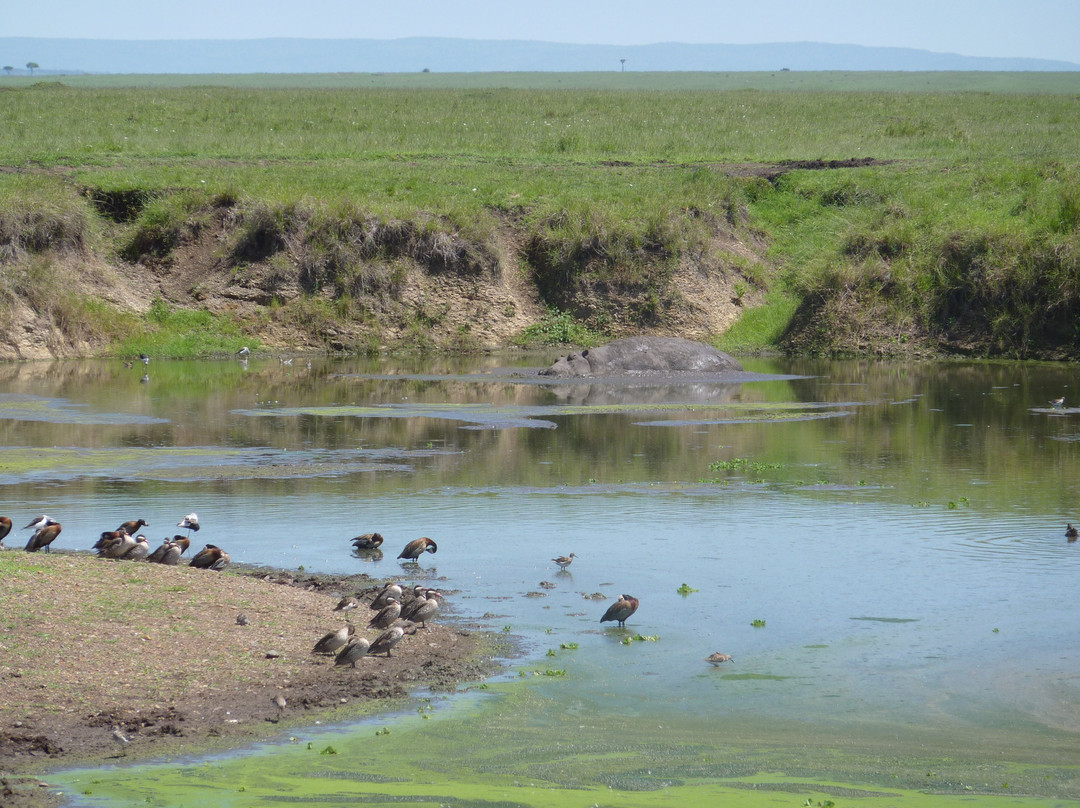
[540,337,743,378]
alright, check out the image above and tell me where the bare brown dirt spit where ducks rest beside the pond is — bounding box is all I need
[0,551,498,807]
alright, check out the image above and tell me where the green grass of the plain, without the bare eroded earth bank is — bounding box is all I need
[0,71,1080,355]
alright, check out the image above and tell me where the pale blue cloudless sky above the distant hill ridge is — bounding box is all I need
[8,0,1080,64]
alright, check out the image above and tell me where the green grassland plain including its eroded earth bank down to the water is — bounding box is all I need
[0,72,1080,359]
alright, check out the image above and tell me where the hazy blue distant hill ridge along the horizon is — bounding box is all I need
[0,37,1080,76]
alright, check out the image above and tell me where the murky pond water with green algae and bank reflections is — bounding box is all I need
[8,356,1080,806]
